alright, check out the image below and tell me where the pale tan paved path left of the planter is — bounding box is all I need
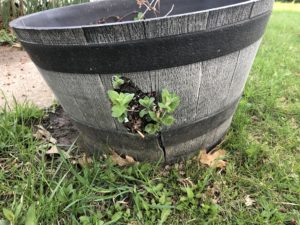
[0,46,54,107]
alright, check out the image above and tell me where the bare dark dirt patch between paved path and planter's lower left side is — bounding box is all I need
[41,106,79,148]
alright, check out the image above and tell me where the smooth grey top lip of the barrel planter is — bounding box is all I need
[9,0,263,31]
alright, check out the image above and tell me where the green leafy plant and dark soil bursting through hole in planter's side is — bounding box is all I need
[108,76,180,137]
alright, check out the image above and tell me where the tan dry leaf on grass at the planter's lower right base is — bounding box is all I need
[198,149,226,169]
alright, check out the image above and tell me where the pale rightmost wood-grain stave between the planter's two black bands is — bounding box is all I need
[226,40,261,104]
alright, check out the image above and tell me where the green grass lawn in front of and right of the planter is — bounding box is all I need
[0,4,300,225]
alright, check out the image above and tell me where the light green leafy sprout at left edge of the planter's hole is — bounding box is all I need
[107,90,134,123]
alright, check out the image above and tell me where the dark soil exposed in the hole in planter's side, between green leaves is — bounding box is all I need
[115,77,158,133]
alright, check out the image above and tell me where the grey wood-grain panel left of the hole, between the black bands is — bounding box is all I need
[40,69,116,130]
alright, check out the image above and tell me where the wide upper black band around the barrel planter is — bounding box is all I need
[22,12,270,74]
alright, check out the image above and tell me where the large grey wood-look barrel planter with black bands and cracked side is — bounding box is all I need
[11,0,273,162]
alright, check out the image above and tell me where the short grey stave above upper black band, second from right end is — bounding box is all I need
[206,2,253,29]
